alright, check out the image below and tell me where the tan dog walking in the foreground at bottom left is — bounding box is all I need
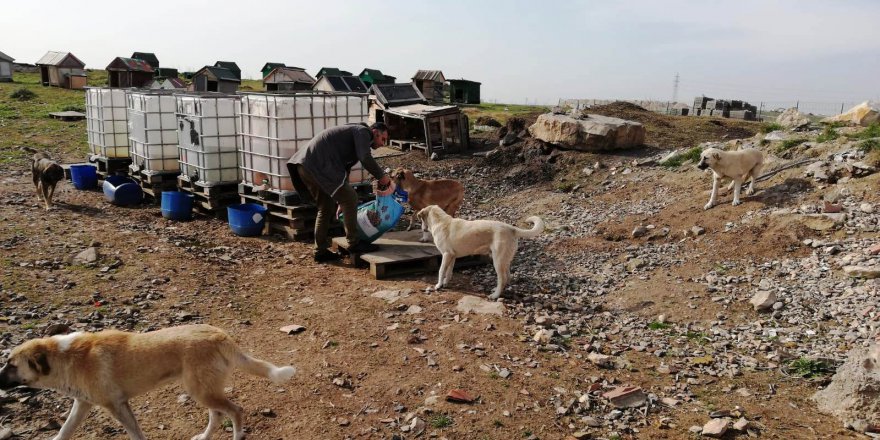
[0,325,296,440]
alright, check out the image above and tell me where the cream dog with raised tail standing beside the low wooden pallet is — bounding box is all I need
[416,205,544,299]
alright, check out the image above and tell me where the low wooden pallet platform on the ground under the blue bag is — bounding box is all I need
[333,231,491,280]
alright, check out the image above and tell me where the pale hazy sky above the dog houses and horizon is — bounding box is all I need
[0,0,880,107]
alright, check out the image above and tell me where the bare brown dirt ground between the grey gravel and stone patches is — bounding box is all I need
[0,102,878,439]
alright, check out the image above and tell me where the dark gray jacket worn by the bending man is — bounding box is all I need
[287,124,385,196]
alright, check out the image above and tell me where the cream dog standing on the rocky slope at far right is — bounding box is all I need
[697,148,764,209]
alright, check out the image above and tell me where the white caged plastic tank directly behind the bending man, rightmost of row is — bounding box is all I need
[238,92,368,191]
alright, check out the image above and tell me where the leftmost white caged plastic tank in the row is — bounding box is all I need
[86,87,129,159]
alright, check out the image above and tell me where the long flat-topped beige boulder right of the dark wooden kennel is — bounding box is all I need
[529,113,645,151]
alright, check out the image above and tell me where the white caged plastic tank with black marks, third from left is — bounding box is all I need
[174,93,241,186]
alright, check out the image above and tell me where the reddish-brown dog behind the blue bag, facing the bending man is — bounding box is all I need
[391,168,464,231]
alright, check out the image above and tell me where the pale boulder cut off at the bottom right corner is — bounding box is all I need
[813,344,880,429]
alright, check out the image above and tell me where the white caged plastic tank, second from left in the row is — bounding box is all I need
[126,90,180,174]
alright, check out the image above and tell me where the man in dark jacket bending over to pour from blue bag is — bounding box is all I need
[287,122,391,263]
